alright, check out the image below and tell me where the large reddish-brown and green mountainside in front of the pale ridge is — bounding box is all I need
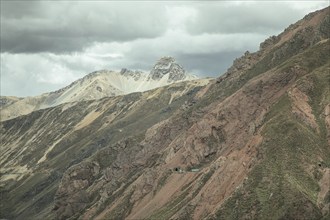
[0,7,330,219]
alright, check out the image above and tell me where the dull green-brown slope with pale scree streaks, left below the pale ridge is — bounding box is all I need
[0,83,204,219]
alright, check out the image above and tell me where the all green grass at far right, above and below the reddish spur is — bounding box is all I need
[216,42,330,219]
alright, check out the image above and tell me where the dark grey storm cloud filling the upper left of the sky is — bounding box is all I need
[1,1,167,53]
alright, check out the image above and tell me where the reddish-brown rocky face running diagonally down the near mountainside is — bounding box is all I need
[50,6,328,219]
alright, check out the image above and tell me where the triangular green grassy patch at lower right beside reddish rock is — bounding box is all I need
[217,87,330,219]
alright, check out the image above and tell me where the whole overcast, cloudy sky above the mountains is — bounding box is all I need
[0,0,329,97]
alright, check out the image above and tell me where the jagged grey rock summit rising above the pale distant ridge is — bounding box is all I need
[149,56,186,82]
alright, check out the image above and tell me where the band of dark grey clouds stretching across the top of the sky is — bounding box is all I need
[1,0,324,54]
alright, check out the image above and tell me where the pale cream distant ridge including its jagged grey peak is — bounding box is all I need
[0,57,197,121]
